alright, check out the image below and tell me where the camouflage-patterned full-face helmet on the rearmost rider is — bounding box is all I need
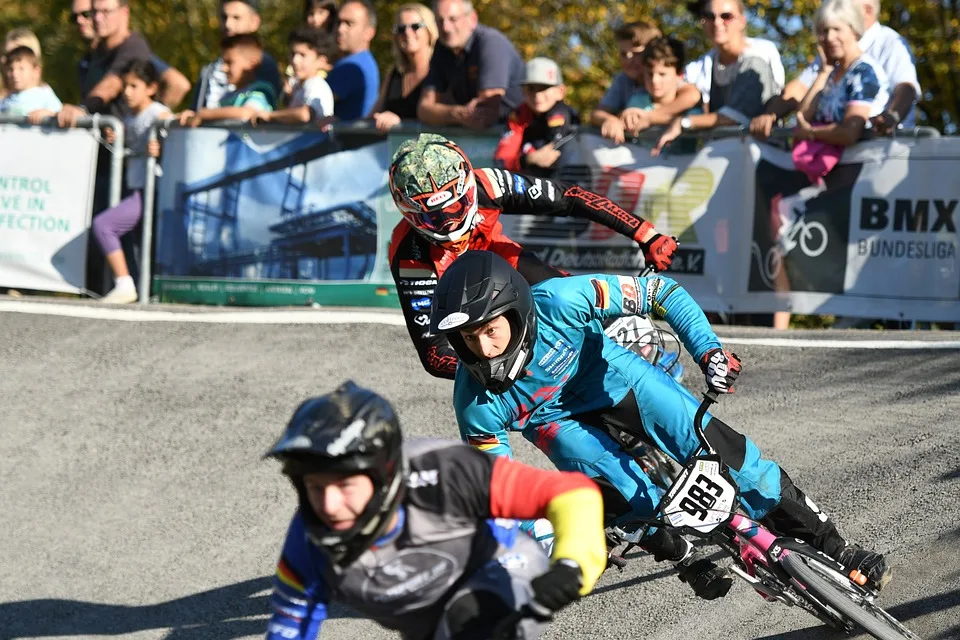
[390,133,480,244]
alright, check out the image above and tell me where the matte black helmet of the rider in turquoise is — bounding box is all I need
[430,251,537,393]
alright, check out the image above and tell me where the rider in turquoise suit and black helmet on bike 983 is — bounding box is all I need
[430,251,890,595]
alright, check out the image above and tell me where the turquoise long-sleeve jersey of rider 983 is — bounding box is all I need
[454,274,721,456]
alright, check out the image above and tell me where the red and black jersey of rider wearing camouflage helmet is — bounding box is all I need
[389,169,652,380]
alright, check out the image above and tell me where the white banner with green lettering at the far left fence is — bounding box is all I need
[0,125,97,293]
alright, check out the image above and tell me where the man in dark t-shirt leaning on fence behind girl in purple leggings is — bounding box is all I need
[57,0,152,127]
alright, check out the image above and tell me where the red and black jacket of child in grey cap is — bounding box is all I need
[493,102,580,175]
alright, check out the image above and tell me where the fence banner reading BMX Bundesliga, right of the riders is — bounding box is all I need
[524,135,960,321]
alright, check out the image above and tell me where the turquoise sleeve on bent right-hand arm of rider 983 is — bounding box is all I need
[636,275,721,362]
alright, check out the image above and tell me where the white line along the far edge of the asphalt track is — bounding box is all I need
[0,300,960,349]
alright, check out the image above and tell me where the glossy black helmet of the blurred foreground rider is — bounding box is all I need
[264,380,403,566]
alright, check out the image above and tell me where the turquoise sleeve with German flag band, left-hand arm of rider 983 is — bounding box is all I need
[453,367,513,458]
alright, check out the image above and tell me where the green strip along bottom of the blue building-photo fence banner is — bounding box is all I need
[153,276,399,308]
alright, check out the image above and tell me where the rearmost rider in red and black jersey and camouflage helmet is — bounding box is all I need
[389,133,677,380]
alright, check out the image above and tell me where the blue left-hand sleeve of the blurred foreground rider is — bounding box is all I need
[266,512,327,640]
